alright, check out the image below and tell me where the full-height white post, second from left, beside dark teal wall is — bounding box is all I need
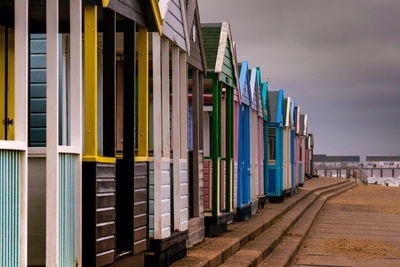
[46,0,59,266]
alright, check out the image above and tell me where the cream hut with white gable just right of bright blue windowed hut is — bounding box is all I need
[283,97,293,195]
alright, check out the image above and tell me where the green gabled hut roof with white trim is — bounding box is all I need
[202,21,238,88]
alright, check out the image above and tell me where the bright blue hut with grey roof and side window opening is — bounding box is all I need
[267,90,285,200]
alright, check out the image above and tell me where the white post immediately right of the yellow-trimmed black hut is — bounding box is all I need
[152,32,162,239]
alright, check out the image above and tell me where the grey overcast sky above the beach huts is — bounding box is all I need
[198,0,400,161]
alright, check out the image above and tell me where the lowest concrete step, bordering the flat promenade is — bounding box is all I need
[259,183,357,267]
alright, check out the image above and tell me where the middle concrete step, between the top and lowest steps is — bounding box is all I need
[217,181,351,266]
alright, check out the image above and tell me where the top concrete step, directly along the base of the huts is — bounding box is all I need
[172,178,351,266]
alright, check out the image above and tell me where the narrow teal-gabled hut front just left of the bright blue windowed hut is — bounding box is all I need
[261,82,271,202]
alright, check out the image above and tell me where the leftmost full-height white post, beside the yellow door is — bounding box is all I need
[13,0,29,266]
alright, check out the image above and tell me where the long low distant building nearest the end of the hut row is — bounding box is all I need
[314,154,360,168]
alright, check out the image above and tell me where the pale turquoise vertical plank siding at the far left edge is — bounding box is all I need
[0,150,21,267]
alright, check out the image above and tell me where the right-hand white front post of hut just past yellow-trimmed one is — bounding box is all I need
[171,46,181,231]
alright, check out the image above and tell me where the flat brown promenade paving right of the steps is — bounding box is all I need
[292,185,400,267]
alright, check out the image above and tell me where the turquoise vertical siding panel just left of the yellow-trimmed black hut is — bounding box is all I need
[59,154,77,267]
